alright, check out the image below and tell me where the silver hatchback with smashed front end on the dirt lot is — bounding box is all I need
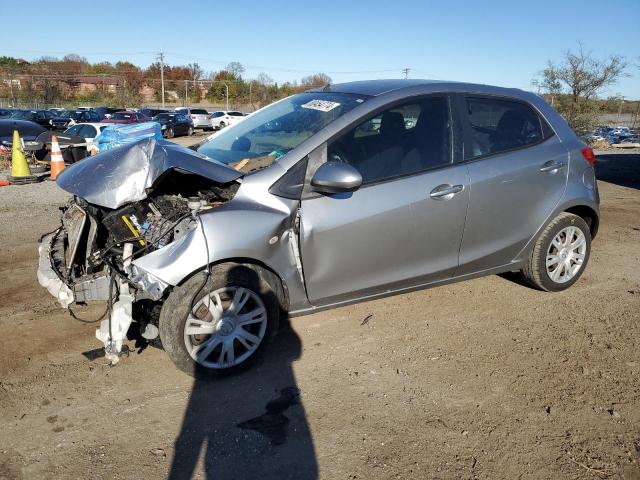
[38,80,599,378]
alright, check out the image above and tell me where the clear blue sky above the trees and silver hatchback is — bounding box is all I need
[0,0,640,98]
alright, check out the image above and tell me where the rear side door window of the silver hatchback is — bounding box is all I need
[465,97,544,159]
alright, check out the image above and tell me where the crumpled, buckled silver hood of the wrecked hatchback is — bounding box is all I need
[57,138,243,208]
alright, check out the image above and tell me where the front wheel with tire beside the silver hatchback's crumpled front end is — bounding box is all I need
[160,263,284,380]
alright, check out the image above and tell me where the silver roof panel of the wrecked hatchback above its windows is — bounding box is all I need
[307,79,523,97]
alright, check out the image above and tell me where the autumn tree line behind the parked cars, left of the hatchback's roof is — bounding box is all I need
[0,54,332,109]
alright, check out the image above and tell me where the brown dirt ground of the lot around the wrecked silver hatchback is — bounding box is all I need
[0,148,640,480]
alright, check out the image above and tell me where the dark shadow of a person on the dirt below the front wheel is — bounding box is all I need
[168,266,318,480]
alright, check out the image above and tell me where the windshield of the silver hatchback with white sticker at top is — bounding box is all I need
[198,92,367,172]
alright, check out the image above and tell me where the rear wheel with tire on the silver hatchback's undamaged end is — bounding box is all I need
[521,212,591,292]
